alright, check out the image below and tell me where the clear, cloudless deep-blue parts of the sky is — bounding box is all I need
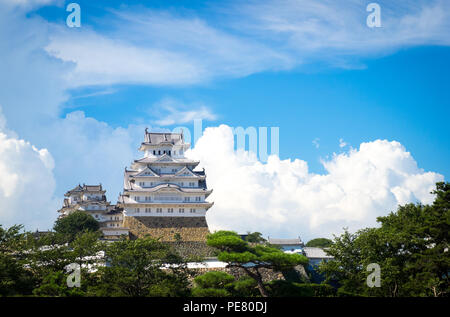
[33,1,450,178]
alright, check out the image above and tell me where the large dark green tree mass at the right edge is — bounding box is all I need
[320,183,450,297]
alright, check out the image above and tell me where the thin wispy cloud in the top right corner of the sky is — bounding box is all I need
[236,0,450,62]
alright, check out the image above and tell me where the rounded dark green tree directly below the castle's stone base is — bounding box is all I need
[90,238,190,297]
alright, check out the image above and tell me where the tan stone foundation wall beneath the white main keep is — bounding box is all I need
[123,216,209,242]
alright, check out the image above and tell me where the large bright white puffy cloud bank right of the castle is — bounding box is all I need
[187,125,443,239]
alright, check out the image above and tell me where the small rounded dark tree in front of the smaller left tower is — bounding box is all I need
[53,211,100,241]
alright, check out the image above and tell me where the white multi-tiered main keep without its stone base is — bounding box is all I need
[118,129,213,217]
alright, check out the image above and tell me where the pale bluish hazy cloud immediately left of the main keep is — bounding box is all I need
[39,111,145,199]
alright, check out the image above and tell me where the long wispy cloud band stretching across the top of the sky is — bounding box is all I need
[47,0,450,87]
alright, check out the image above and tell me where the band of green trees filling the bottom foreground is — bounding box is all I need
[0,183,450,297]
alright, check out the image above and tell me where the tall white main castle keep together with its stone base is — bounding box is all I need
[118,129,213,241]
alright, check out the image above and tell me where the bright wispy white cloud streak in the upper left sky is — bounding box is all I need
[46,9,291,87]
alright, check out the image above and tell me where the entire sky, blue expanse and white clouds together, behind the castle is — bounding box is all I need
[0,0,450,236]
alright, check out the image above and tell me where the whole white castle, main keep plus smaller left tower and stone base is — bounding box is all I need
[58,129,213,241]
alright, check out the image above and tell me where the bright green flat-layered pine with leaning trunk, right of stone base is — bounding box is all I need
[207,231,308,297]
